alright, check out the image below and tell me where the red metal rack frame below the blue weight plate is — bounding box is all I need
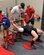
[4,29,14,48]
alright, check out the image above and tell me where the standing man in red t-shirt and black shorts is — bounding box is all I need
[26,5,35,26]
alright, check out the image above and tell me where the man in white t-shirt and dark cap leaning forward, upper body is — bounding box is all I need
[10,3,25,20]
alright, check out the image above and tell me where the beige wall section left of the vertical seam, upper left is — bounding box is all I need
[0,0,15,10]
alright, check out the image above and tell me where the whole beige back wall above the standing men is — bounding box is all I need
[0,0,43,17]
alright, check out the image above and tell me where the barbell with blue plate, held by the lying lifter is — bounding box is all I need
[0,17,22,29]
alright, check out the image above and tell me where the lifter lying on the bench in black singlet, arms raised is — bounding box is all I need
[11,18,43,49]
